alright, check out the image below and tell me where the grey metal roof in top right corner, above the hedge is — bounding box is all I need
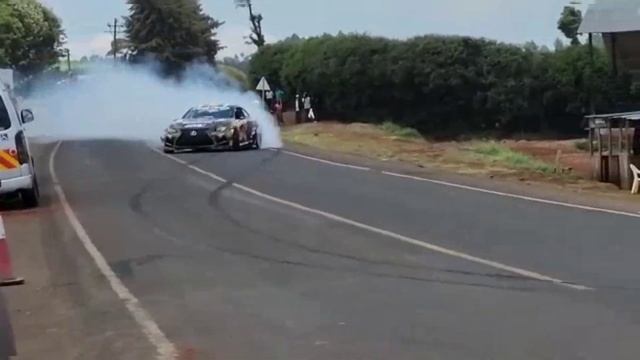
[578,0,640,34]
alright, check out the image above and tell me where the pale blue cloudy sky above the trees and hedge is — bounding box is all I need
[41,0,591,58]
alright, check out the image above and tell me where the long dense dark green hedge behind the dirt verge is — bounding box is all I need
[249,34,640,135]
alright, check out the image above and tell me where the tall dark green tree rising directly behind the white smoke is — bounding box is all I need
[126,0,223,74]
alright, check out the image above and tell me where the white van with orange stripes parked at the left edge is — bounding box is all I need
[0,86,40,207]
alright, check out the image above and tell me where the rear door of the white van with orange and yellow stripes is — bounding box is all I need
[0,92,22,180]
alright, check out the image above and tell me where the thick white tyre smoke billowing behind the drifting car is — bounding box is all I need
[25,65,282,147]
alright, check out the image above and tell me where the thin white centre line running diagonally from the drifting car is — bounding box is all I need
[156,151,594,291]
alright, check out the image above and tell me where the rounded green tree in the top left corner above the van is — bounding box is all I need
[0,0,64,75]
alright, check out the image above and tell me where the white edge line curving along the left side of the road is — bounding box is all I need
[49,141,178,360]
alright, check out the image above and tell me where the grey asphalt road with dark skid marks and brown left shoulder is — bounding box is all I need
[6,140,640,360]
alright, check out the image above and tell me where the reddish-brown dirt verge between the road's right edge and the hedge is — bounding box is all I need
[282,122,640,213]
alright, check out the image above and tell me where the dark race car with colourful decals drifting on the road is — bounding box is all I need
[161,105,262,153]
